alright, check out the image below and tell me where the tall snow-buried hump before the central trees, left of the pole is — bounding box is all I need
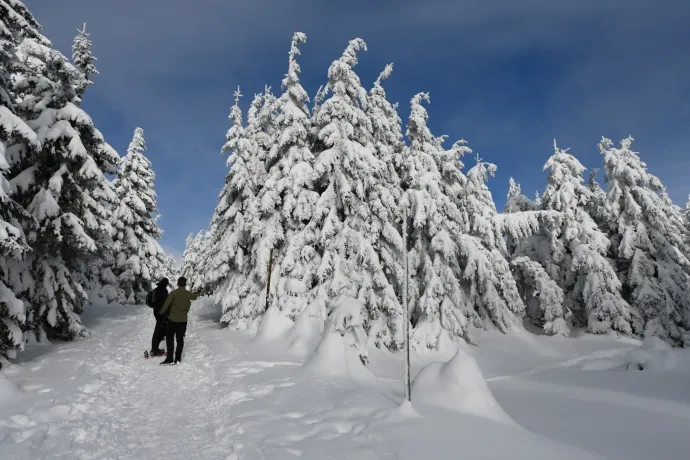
[304,296,376,383]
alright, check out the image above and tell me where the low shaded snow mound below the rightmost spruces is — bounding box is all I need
[580,337,680,372]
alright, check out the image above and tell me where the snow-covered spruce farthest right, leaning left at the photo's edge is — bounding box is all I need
[599,137,690,345]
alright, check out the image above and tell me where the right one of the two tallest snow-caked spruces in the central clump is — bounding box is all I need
[309,39,402,349]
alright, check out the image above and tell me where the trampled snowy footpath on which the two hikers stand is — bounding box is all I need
[0,309,236,459]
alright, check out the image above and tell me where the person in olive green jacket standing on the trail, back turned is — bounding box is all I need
[160,276,199,365]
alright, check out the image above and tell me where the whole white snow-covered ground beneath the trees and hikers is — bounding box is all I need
[0,301,690,460]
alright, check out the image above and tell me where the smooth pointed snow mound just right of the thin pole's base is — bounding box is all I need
[411,348,515,424]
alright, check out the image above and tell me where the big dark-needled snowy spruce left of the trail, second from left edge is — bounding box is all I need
[6,10,118,339]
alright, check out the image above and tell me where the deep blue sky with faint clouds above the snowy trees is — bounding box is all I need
[24,0,690,256]
